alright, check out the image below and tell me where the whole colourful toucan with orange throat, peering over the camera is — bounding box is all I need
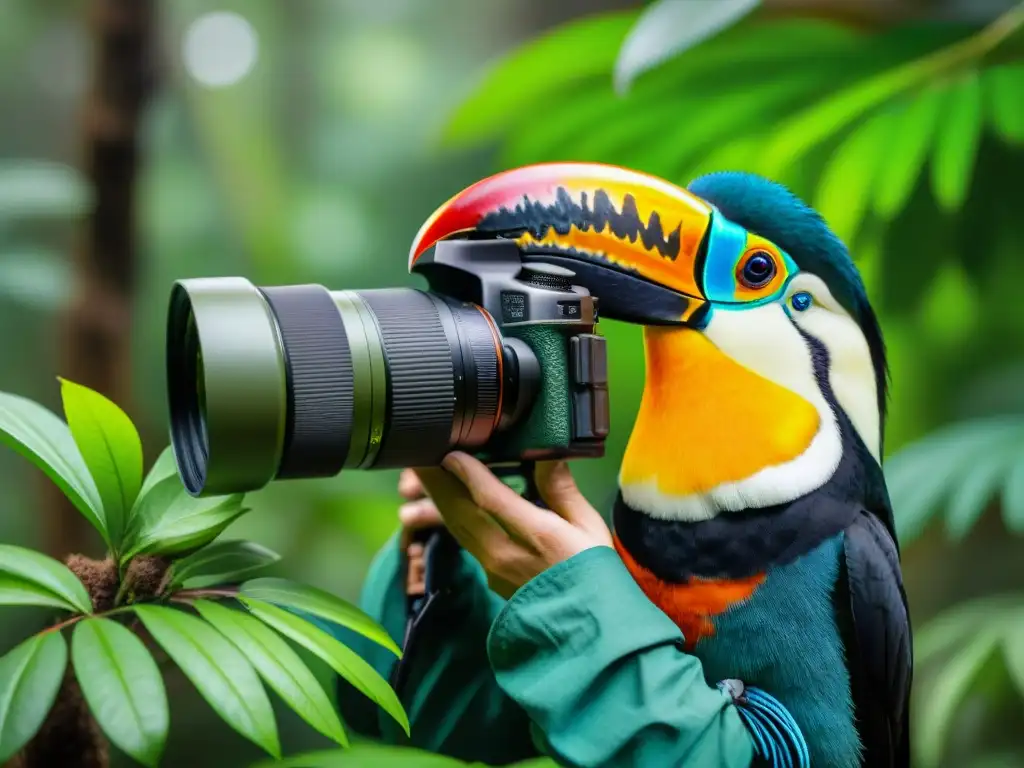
[410,163,912,768]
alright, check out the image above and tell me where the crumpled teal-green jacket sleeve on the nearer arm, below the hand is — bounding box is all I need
[487,547,754,768]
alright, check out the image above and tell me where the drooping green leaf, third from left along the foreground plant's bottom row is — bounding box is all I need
[135,605,281,758]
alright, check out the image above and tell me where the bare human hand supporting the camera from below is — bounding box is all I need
[409,452,612,598]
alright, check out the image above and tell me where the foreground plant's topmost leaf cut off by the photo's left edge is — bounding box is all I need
[0,392,110,545]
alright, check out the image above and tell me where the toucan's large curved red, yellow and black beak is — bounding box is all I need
[409,163,713,324]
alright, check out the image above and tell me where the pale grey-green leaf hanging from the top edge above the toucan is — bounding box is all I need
[614,0,761,93]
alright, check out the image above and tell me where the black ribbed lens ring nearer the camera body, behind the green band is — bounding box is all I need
[359,288,455,468]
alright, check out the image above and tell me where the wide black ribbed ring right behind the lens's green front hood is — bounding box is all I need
[261,285,353,479]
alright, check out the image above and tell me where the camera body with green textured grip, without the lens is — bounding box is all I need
[413,240,609,464]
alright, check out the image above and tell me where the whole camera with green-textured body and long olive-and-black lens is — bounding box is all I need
[167,240,608,496]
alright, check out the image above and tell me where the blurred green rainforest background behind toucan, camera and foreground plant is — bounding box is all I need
[0,0,1024,768]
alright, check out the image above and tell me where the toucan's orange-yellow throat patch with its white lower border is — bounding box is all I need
[620,328,839,520]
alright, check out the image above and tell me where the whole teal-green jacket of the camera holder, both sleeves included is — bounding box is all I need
[339,540,754,768]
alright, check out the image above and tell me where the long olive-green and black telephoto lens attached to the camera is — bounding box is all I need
[167,278,540,496]
